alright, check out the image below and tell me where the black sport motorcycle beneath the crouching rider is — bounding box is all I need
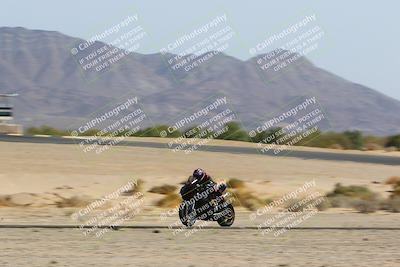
[179,178,235,227]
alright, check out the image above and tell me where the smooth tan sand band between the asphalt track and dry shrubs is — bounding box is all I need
[0,142,399,201]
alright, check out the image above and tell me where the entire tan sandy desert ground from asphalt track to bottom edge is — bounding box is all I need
[0,142,400,267]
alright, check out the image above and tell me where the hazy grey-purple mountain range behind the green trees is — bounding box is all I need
[0,27,400,135]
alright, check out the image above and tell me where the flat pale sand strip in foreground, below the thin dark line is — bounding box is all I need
[0,229,400,267]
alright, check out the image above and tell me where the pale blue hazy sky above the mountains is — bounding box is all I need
[0,0,400,100]
